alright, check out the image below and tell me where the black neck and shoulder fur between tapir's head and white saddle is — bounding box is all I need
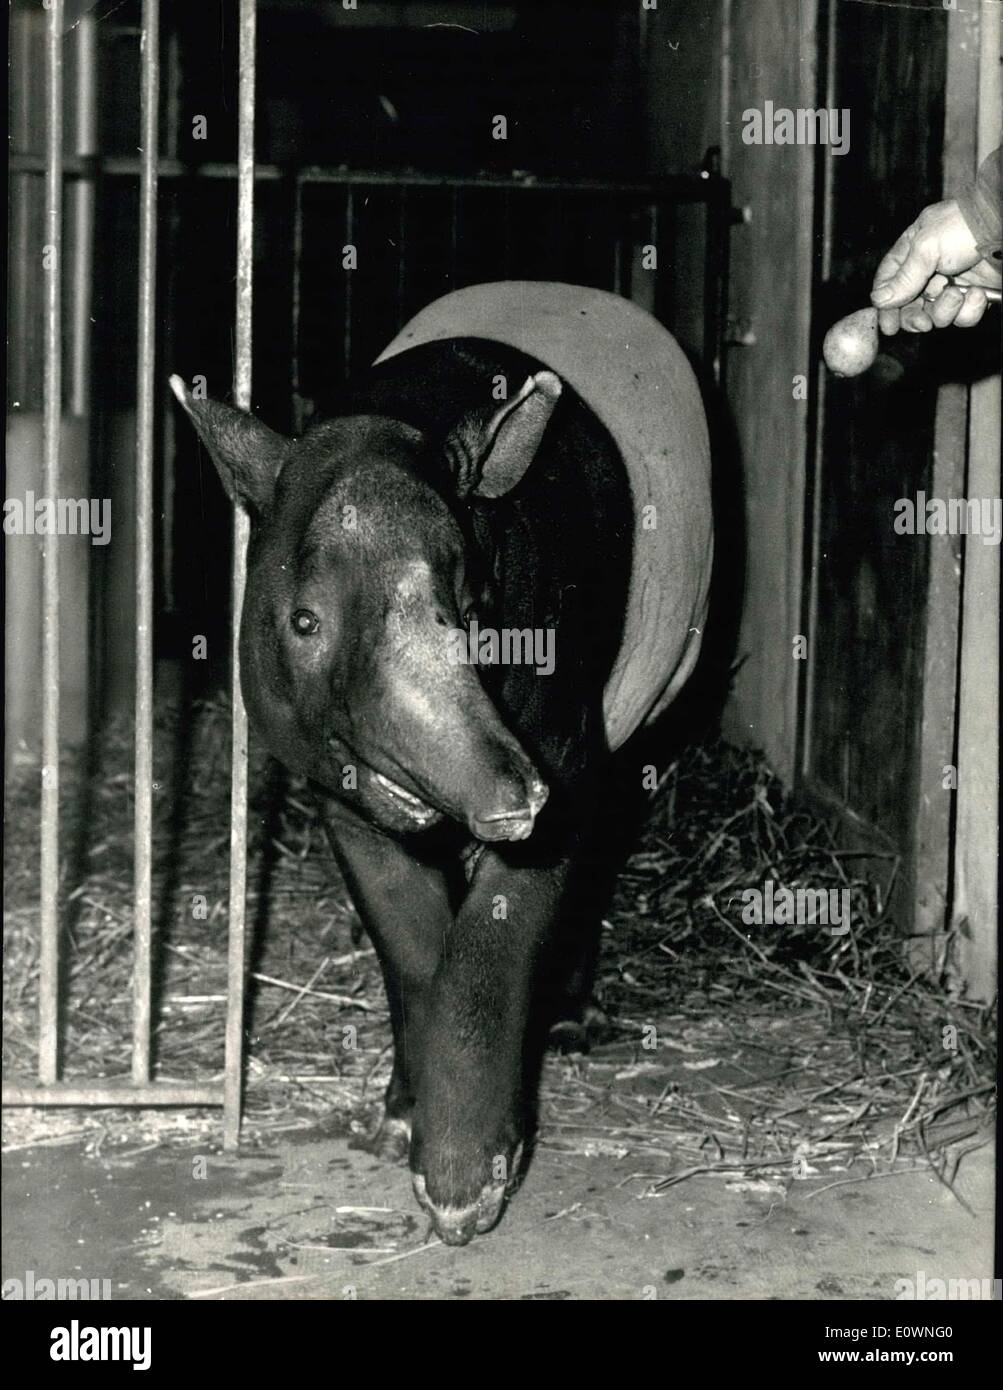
[345,339,633,811]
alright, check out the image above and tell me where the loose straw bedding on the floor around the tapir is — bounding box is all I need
[4,701,996,1191]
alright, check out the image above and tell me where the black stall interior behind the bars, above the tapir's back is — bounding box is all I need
[10,0,704,720]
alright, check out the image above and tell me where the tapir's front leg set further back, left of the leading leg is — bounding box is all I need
[318,792,453,1158]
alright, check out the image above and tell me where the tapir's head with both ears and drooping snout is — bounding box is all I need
[171,373,560,841]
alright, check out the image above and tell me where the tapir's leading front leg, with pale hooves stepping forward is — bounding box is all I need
[411,849,568,1245]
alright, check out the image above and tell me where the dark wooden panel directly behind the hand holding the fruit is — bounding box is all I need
[803,0,949,861]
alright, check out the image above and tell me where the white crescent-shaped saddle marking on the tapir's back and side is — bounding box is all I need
[376,279,713,749]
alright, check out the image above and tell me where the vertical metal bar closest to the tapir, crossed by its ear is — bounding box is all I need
[222,0,257,1148]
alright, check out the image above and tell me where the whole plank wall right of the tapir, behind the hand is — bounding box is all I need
[642,0,1000,997]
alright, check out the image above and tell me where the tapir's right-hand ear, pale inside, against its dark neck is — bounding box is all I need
[446,371,561,498]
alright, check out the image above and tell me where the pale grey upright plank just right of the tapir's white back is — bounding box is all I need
[722,0,816,778]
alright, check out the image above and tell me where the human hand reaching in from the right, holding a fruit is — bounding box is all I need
[871,199,1000,334]
